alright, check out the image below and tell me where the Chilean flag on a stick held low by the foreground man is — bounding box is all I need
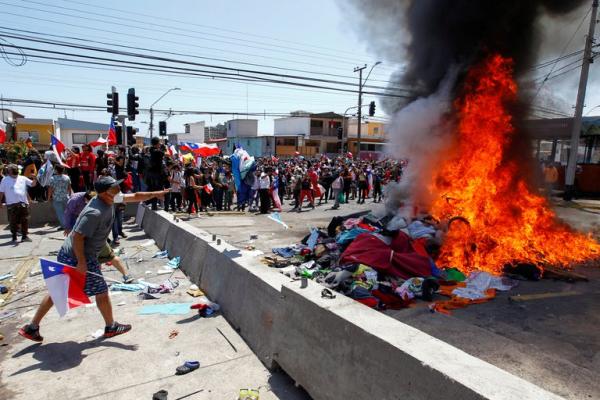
[40,258,91,317]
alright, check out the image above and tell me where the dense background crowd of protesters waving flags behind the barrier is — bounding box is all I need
[2,138,404,242]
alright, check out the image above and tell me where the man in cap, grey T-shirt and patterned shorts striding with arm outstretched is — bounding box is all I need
[19,176,164,342]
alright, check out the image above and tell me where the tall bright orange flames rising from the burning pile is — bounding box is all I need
[429,55,600,273]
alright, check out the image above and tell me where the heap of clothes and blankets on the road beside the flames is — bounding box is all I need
[264,212,524,313]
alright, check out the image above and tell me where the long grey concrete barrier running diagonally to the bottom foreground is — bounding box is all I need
[141,209,559,400]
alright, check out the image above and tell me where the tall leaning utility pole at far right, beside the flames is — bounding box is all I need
[564,0,598,201]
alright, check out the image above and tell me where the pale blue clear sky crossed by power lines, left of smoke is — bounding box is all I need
[0,0,398,133]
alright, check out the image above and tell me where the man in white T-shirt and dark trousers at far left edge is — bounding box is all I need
[0,164,37,242]
